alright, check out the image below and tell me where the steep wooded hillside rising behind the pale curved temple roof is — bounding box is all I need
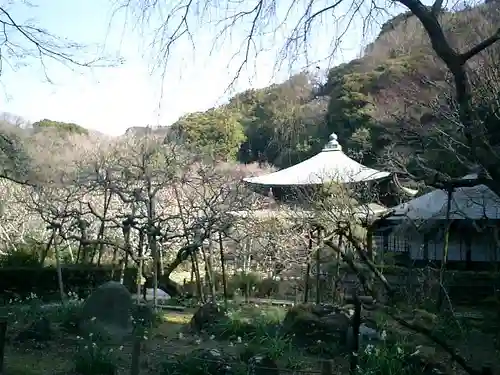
[173,2,500,181]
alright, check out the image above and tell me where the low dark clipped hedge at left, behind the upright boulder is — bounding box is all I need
[0,266,141,303]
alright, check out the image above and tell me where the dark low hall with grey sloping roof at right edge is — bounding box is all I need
[372,173,500,270]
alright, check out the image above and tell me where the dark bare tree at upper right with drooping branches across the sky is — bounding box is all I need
[113,0,500,192]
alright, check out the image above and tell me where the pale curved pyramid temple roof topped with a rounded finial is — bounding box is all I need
[243,133,390,186]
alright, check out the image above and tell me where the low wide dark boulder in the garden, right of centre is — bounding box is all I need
[282,304,351,346]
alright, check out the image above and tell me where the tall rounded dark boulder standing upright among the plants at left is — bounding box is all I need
[80,281,133,341]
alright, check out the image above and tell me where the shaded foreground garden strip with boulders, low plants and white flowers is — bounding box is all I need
[0,268,498,375]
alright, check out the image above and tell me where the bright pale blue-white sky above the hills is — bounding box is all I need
[0,0,400,135]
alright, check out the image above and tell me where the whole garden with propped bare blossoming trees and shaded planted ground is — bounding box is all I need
[0,129,500,375]
